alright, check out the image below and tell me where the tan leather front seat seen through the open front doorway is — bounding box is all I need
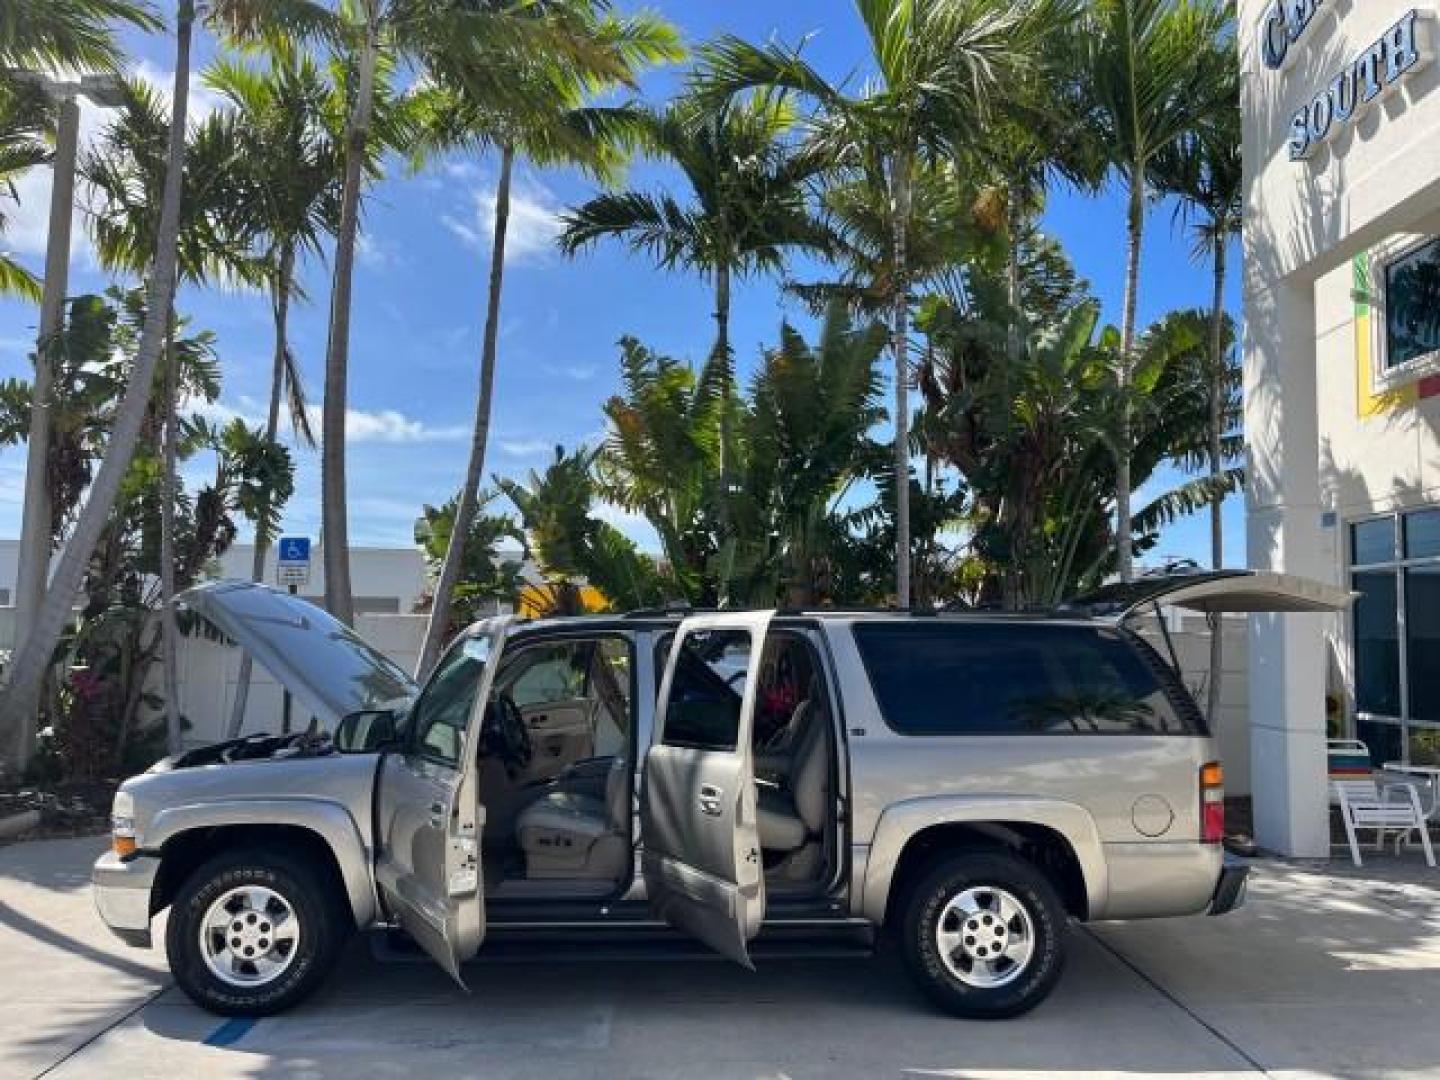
[516,756,631,880]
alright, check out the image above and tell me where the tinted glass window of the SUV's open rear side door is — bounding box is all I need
[661,631,750,750]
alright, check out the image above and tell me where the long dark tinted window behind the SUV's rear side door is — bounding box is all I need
[854,621,1204,736]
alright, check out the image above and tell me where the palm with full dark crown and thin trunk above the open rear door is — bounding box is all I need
[560,86,827,558]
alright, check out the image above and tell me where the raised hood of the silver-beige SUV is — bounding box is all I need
[176,582,419,730]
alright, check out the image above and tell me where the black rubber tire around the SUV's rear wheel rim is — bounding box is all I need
[899,851,1066,1020]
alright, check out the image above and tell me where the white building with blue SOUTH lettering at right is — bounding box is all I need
[1238,0,1440,855]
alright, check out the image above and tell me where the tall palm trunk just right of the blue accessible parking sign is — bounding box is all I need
[320,10,380,624]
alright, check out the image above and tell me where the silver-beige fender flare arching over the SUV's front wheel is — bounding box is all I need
[144,798,379,927]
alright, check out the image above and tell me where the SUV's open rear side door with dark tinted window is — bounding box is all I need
[641,612,773,968]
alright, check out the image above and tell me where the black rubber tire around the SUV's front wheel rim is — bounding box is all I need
[166,850,353,1017]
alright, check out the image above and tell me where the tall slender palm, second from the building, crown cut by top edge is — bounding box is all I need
[1076,0,1236,582]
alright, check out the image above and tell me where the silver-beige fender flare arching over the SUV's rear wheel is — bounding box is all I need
[861,795,1109,926]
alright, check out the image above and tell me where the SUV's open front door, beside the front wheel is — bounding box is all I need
[376,616,513,986]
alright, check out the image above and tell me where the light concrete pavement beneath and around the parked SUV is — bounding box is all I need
[0,840,1440,1080]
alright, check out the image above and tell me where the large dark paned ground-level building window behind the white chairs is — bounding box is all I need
[1349,510,1440,765]
